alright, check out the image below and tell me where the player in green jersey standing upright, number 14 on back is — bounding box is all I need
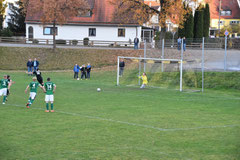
[44,78,56,112]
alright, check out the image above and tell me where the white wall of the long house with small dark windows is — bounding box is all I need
[26,24,141,41]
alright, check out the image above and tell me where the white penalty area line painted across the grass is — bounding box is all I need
[2,104,240,132]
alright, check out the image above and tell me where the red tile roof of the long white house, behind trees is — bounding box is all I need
[26,0,140,25]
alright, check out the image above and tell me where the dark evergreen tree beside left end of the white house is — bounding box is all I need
[8,1,26,33]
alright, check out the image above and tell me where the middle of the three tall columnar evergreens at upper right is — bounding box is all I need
[194,6,204,38]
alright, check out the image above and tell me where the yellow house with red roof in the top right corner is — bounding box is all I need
[209,0,240,37]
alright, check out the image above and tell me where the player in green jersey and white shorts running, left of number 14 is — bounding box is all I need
[25,77,45,108]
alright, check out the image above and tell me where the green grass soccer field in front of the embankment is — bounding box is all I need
[0,72,240,160]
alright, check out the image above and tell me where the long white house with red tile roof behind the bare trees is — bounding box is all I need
[26,0,142,42]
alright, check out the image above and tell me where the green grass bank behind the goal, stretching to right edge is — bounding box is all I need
[120,70,240,89]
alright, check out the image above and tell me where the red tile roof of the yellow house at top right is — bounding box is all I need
[209,0,240,19]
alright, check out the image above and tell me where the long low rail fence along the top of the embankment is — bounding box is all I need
[0,37,240,50]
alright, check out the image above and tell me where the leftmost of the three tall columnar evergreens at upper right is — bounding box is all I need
[184,7,194,39]
